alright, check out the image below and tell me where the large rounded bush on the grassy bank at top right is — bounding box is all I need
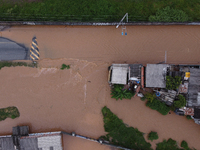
[149,6,189,22]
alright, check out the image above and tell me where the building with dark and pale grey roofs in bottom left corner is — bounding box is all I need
[0,126,63,150]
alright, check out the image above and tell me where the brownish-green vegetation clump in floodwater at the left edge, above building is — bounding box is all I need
[0,107,20,121]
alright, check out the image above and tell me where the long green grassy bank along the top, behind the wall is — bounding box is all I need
[0,0,200,22]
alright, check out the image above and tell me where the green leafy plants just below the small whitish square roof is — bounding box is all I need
[111,84,135,100]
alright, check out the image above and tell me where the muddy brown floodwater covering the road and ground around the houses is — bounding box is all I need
[0,26,200,150]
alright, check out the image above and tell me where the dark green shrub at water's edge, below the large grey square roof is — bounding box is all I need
[146,99,170,115]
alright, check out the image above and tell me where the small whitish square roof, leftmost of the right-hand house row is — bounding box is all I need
[111,64,128,84]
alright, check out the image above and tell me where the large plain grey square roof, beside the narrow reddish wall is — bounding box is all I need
[146,64,169,88]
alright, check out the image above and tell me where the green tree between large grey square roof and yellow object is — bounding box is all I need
[166,76,181,90]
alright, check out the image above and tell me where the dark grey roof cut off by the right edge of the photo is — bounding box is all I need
[187,68,200,107]
